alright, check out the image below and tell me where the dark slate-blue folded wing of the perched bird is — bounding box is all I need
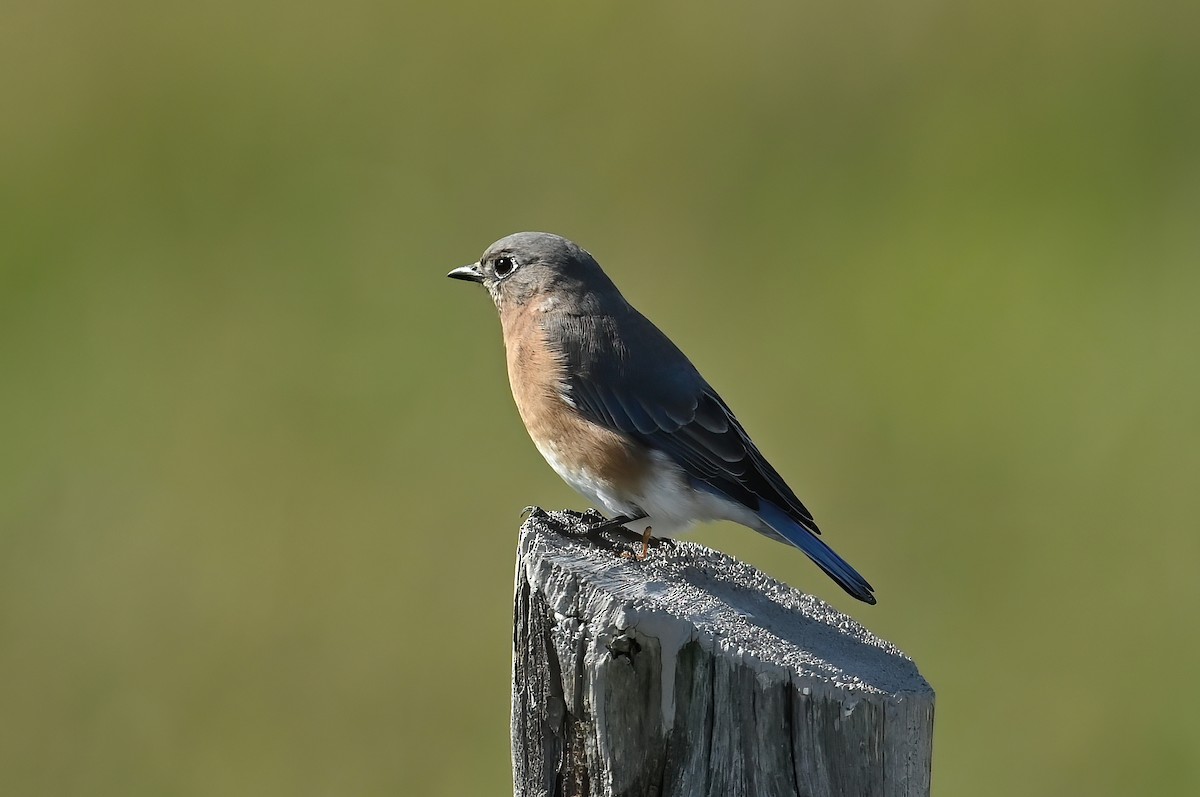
[544,308,820,534]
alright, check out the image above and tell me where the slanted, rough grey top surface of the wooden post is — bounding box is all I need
[518,511,932,699]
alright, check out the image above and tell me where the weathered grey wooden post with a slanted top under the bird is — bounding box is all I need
[512,513,934,797]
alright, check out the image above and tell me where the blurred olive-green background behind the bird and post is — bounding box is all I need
[0,0,1200,797]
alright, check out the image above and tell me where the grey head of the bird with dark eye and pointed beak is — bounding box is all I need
[446,233,624,311]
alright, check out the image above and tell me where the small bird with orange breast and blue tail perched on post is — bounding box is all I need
[446,232,876,604]
